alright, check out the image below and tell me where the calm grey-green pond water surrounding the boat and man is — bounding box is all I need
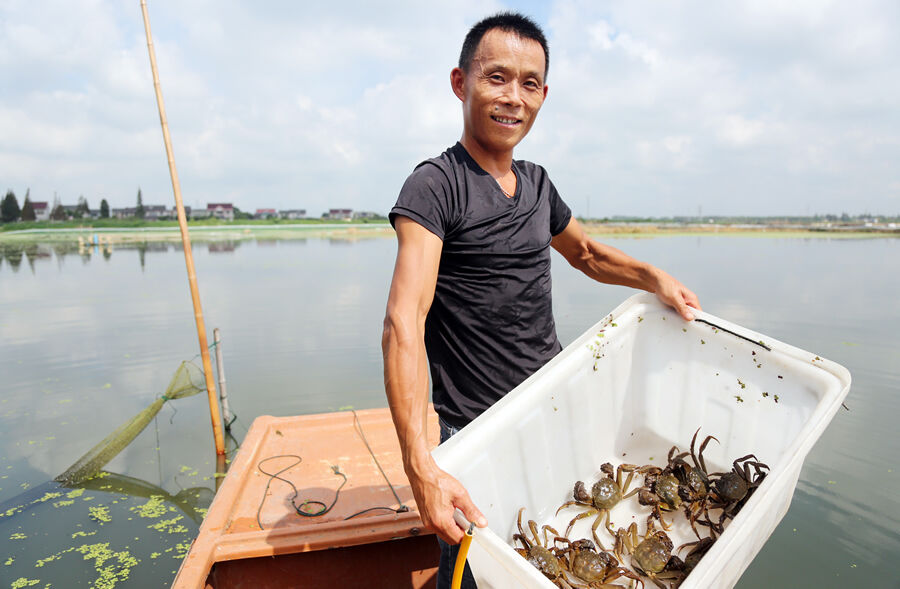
[0,235,900,588]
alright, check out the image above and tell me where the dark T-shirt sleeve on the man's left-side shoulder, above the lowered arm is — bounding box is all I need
[388,162,452,239]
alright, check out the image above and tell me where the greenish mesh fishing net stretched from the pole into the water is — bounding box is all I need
[54,362,206,485]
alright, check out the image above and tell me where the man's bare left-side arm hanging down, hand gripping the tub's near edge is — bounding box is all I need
[381,217,487,544]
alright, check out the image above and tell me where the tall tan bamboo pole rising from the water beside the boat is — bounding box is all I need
[141,0,225,455]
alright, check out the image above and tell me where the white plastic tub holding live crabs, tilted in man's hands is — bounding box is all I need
[433,294,850,589]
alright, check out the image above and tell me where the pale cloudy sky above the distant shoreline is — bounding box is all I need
[0,0,900,217]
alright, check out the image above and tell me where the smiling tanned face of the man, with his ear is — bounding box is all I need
[451,29,547,152]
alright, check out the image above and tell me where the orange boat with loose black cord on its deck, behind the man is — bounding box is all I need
[173,408,439,589]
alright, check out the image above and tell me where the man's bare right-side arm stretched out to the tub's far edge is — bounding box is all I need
[551,217,700,321]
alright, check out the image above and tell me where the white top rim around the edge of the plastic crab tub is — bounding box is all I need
[433,293,851,589]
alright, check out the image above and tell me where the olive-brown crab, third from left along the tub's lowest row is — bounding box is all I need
[615,516,684,589]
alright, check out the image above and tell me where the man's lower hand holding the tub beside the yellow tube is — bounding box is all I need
[407,457,487,544]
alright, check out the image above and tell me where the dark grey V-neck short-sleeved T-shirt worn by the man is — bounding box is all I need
[390,143,572,427]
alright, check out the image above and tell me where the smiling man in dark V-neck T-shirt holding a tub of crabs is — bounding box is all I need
[382,13,700,587]
